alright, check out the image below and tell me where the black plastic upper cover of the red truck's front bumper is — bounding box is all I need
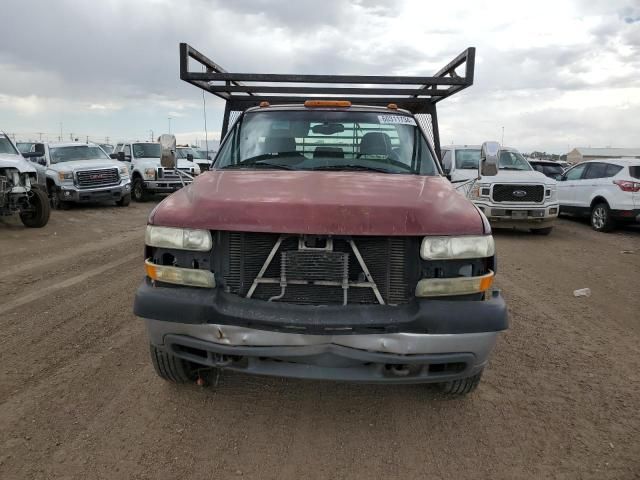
[134,279,509,335]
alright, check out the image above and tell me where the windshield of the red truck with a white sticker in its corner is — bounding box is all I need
[216,110,439,175]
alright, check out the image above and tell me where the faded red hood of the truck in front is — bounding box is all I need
[149,170,484,236]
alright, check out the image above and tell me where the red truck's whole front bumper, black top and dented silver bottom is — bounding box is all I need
[134,281,508,383]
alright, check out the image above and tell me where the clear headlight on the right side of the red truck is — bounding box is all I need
[420,235,496,260]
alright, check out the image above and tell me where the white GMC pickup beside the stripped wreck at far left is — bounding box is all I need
[30,142,131,209]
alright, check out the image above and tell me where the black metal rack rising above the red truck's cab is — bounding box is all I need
[180,43,476,155]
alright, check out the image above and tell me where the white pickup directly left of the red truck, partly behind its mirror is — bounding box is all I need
[111,142,200,202]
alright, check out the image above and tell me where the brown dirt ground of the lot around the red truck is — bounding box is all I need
[0,203,640,480]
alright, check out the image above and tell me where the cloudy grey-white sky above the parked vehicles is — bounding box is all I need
[0,0,640,153]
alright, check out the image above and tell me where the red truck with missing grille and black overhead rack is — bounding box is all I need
[134,44,508,395]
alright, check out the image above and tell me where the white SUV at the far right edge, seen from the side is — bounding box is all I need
[558,158,640,232]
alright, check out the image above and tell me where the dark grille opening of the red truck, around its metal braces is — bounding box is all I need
[222,232,419,305]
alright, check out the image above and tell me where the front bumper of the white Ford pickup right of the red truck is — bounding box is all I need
[474,201,560,228]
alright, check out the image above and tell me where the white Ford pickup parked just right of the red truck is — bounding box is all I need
[441,145,559,235]
